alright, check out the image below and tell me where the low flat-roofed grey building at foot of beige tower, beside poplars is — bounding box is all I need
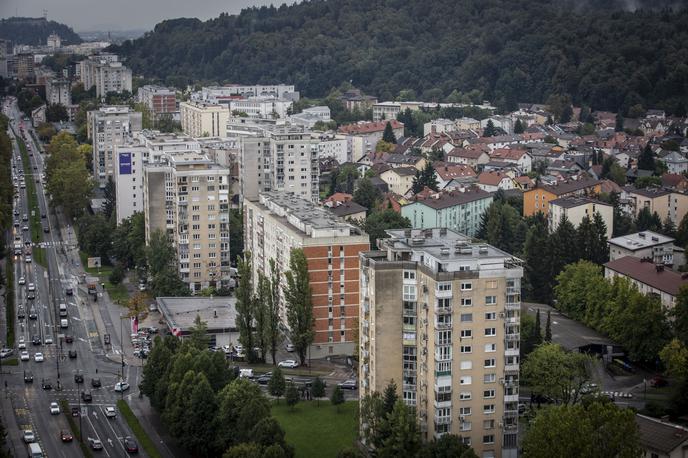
[155,296,239,347]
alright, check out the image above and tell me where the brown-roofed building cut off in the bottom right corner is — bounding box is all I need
[635,414,688,458]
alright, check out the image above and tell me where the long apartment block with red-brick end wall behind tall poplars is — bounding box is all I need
[244,192,370,358]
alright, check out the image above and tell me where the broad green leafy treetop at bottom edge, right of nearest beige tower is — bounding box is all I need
[523,400,642,458]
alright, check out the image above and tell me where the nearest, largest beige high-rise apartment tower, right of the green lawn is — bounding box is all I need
[359,228,523,458]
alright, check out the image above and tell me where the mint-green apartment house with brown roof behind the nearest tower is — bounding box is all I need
[401,187,492,236]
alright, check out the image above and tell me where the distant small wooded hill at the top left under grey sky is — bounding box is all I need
[0,17,82,46]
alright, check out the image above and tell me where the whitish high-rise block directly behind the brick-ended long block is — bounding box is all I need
[239,125,320,202]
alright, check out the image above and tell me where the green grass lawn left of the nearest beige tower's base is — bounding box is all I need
[272,399,358,458]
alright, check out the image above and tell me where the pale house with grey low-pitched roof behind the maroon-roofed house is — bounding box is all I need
[607,231,685,267]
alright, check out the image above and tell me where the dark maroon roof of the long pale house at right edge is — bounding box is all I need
[604,256,688,296]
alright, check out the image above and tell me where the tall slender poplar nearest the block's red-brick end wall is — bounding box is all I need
[284,249,315,366]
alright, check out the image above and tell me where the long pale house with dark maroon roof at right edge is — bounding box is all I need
[604,256,688,309]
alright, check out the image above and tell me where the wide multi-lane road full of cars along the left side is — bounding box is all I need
[0,98,144,458]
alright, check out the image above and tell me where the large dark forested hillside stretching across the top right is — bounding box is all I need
[113,0,688,114]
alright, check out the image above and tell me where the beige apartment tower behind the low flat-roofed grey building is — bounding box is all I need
[143,152,230,292]
